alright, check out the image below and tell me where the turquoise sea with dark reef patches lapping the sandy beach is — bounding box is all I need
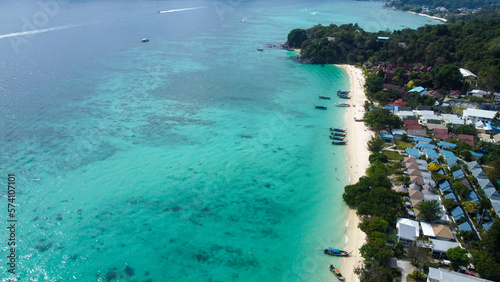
[0,0,438,281]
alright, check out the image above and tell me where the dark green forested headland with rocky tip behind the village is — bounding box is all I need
[289,10,500,91]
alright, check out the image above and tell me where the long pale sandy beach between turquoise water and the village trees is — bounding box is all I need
[339,65,372,281]
